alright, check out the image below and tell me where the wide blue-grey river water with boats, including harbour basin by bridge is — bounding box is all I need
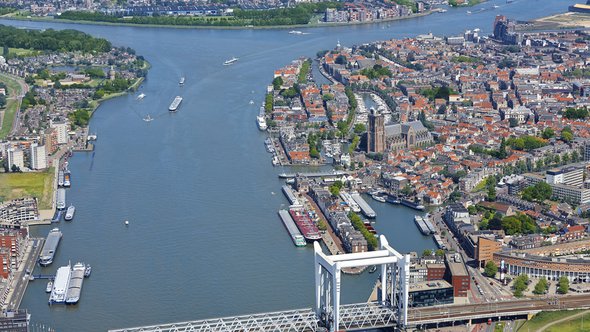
[0,0,580,331]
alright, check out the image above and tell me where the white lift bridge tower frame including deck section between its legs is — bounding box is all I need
[314,235,410,332]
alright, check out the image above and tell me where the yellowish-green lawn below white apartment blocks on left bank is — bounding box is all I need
[0,168,55,210]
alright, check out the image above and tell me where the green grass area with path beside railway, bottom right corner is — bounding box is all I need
[518,310,590,332]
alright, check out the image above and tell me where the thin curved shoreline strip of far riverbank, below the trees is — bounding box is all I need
[2,10,438,30]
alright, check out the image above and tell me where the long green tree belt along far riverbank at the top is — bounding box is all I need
[58,2,342,26]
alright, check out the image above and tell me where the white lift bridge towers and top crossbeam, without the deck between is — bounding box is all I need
[314,235,410,332]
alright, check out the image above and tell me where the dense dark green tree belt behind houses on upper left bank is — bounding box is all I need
[0,25,111,52]
